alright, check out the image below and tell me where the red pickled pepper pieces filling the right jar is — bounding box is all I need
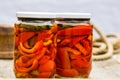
[56,25,92,77]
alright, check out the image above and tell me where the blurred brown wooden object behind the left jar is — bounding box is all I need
[0,24,14,58]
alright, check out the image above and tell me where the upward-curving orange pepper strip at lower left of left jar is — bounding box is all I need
[15,59,38,73]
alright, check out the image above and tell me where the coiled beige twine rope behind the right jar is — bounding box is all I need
[92,23,120,60]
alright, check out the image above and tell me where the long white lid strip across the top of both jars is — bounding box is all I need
[16,12,91,19]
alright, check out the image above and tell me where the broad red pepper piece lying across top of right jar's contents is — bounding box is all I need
[58,25,92,36]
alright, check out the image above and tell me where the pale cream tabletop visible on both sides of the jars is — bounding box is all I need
[0,54,120,80]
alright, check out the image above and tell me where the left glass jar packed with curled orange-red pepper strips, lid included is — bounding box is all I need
[14,12,56,78]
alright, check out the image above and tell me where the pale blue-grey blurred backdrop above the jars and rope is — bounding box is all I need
[0,0,120,33]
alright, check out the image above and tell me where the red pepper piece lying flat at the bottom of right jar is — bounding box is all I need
[57,68,79,77]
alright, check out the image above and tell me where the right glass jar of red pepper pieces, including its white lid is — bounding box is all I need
[55,13,92,78]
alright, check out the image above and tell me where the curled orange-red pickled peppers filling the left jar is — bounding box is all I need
[14,24,55,78]
